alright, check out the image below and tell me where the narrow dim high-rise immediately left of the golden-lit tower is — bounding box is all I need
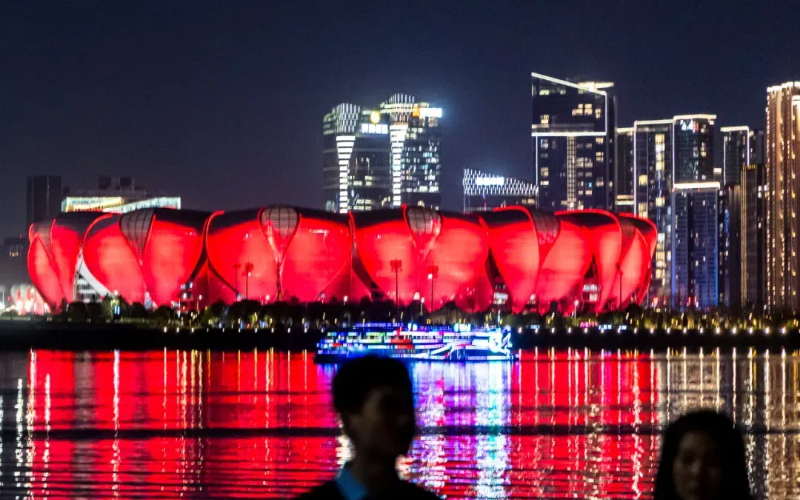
[741,163,767,309]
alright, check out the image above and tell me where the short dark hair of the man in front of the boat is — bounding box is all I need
[333,355,411,415]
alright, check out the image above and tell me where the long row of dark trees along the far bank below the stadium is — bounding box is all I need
[14,296,800,330]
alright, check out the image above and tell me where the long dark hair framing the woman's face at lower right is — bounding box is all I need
[653,411,752,500]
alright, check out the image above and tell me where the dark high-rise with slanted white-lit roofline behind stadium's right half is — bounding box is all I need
[531,73,616,211]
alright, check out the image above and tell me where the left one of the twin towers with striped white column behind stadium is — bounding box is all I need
[322,103,392,213]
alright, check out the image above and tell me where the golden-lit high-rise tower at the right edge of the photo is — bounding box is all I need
[766,82,800,312]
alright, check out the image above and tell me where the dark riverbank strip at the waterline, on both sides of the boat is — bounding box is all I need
[0,321,800,351]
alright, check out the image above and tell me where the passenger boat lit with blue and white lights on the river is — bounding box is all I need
[314,323,515,364]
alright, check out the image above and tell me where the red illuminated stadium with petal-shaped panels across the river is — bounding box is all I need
[28,206,656,313]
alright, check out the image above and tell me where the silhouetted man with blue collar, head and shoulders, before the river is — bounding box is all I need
[299,356,438,500]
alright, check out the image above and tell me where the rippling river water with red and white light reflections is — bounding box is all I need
[0,350,800,499]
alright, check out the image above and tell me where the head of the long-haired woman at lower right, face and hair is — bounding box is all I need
[654,411,751,500]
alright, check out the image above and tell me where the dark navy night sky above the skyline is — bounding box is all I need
[0,0,800,236]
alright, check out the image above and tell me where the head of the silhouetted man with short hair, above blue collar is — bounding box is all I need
[333,356,416,460]
